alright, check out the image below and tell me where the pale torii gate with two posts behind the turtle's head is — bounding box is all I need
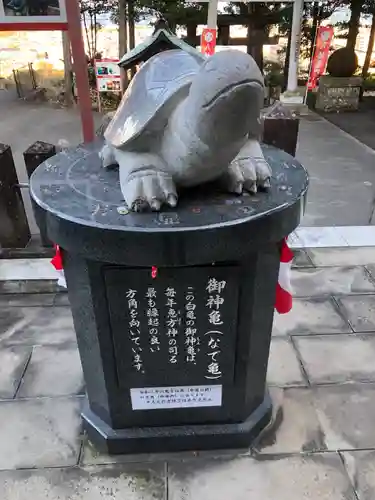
[203,0,311,92]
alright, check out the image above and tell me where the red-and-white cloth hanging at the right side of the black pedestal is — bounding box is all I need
[275,240,294,314]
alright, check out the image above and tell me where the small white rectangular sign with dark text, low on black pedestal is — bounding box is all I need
[130,385,222,410]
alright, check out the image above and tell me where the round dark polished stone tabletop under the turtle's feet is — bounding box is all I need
[30,142,308,265]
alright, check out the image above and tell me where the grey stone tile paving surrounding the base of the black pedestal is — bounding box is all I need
[0,248,375,500]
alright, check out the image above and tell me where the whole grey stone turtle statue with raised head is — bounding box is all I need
[100,50,271,211]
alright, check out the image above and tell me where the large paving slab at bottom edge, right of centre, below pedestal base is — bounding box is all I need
[168,454,356,500]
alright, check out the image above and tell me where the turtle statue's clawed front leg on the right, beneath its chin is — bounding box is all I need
[223,139,272,194]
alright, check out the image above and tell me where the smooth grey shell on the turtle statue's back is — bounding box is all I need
[104,49,205,147]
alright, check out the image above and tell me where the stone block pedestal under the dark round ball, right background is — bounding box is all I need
[315,75,362,113]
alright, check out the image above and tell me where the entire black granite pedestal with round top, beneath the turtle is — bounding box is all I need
[31,144,307,453]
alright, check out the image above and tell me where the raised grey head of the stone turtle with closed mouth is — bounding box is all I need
[188,50,264,143]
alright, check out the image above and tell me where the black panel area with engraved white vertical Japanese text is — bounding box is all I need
[105,266,239,389]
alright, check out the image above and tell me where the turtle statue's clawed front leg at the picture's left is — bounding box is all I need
[114,149,177,212]
